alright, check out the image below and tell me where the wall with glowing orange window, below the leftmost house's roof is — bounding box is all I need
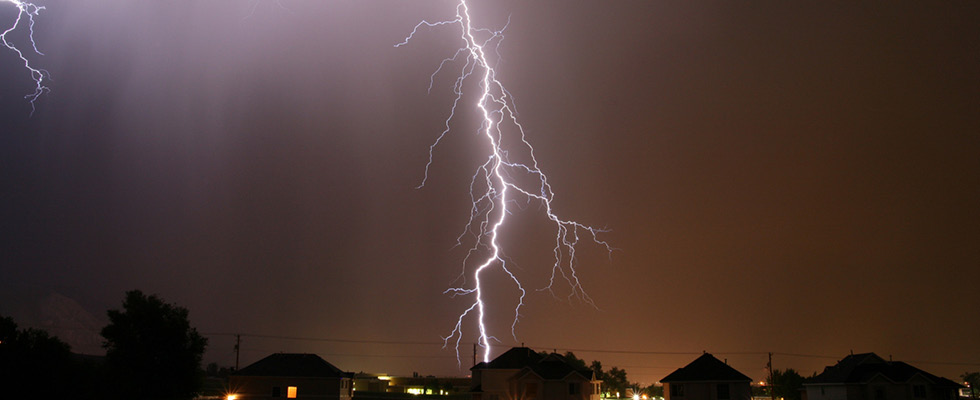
[228,375,353,400]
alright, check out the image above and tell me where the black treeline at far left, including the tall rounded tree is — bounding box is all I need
[0,290,207,400]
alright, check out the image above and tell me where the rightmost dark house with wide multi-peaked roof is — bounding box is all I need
[803,353,962,400]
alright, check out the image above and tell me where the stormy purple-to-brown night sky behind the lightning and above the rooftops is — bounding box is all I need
[0,0,980,383]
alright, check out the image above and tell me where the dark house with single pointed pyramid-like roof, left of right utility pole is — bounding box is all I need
[660,353,752,400]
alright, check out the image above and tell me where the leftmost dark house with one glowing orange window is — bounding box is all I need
[228,353,354,400]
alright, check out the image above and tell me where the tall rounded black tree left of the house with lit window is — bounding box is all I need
[102,290,207,400]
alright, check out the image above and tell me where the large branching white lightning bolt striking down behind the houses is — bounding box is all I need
[395,0,613,363]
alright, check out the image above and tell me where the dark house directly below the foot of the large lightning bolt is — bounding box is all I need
[470,347,602,400]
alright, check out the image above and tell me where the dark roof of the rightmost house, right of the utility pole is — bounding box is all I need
[806,353,961,388]
